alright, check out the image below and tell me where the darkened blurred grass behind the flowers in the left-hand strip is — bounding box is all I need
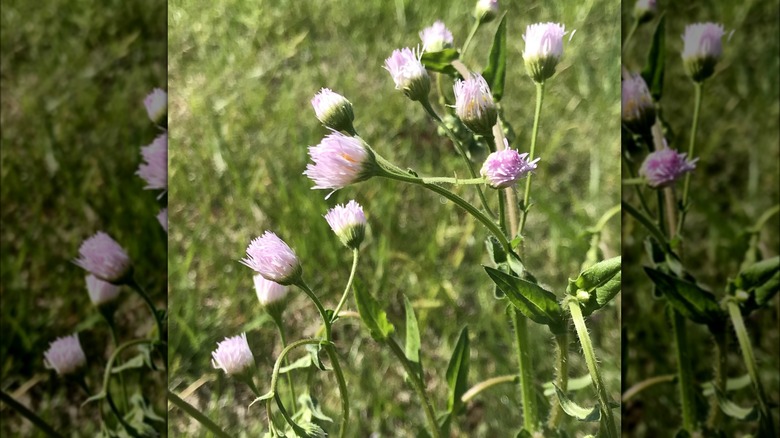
[0,0,167,436]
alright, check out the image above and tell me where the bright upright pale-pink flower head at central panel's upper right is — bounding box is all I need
[523,23,566,82]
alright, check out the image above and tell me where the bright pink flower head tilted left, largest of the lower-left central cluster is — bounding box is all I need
[241,231,303,286]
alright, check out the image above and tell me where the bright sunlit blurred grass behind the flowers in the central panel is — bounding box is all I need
[169,0,620,437]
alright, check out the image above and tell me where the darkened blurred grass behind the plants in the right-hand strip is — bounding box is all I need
[622,1,780,437]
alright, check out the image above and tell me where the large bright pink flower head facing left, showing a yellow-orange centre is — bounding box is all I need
[303,132,374,196]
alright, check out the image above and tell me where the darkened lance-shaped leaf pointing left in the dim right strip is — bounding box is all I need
[645,267,724,325]
